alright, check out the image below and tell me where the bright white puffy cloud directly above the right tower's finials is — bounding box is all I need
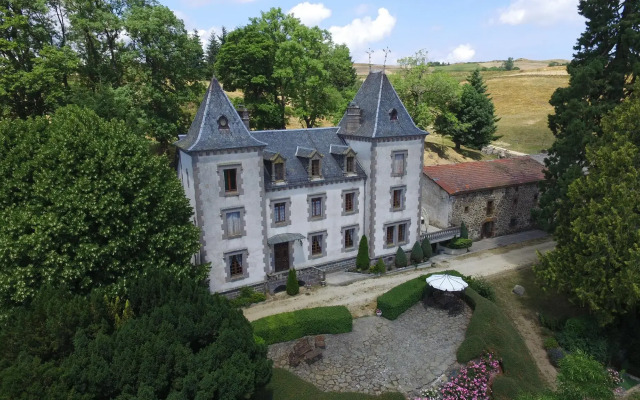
[329,8,397,51]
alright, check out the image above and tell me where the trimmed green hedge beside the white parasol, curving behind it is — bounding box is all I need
[378,270,462,320]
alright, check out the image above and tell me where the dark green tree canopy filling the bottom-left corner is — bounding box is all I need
[0,272,272,399]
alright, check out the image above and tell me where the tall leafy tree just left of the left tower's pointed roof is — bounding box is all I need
[124,5,203,147]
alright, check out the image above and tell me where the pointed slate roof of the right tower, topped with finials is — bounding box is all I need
[338,72,427,138]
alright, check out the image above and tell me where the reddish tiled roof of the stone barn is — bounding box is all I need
[423,156,544,195]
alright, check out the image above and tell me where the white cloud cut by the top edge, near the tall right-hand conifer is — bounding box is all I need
[498,0,578,25]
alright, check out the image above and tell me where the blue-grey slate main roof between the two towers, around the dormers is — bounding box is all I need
[252,127,366,188]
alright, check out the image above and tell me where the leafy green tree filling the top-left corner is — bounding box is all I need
[0,0,78,119]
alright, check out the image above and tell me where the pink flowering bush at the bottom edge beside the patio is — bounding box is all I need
[414,353,500,400]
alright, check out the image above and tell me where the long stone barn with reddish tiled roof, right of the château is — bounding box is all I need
[422,156,544,240]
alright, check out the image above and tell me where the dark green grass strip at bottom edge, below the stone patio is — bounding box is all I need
[253,368,404,400]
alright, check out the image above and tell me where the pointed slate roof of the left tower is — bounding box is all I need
[175,77,265,152]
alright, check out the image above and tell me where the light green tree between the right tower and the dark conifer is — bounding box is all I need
[391,50,461,133]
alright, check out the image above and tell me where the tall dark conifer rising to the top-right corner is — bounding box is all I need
[534,0,640,232]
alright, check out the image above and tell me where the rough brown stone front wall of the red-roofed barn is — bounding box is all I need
[450,183,539,240]
